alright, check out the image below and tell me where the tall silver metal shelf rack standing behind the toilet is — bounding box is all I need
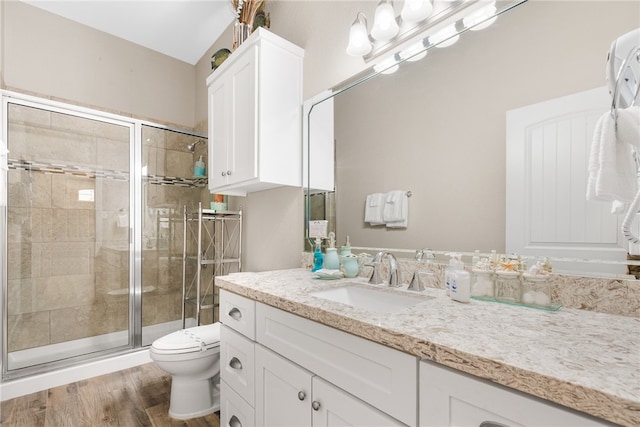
[182,203,242,328]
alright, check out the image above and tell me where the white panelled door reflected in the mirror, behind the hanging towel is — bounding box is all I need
[506,87,627,274]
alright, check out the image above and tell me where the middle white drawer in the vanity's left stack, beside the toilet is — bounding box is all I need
[220,325,255,406]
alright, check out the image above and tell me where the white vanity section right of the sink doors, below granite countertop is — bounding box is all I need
[419,362,610,427]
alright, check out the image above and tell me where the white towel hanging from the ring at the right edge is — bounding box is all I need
[587,111,636,202]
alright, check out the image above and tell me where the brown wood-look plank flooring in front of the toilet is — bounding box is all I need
[0,363,220,427]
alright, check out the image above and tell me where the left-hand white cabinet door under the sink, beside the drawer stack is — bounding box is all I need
[255,344,312,427]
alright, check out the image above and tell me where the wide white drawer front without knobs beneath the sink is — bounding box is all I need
[256,303,418,426]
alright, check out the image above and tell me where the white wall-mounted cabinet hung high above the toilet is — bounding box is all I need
[207,28,304,196]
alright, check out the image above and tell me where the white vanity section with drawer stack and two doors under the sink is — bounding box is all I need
[220,290,418,427]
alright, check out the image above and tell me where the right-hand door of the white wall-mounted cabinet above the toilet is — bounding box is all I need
[223,47,259,184]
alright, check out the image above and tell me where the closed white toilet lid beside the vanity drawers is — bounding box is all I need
[151,322,220,354]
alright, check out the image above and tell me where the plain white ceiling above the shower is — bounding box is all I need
[22,0,233,64]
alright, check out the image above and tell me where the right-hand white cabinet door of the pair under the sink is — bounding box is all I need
[311,377,405,427]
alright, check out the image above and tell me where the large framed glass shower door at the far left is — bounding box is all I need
[5,101,134,371]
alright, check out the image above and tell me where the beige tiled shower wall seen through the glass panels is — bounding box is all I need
[7,104,208,351]
